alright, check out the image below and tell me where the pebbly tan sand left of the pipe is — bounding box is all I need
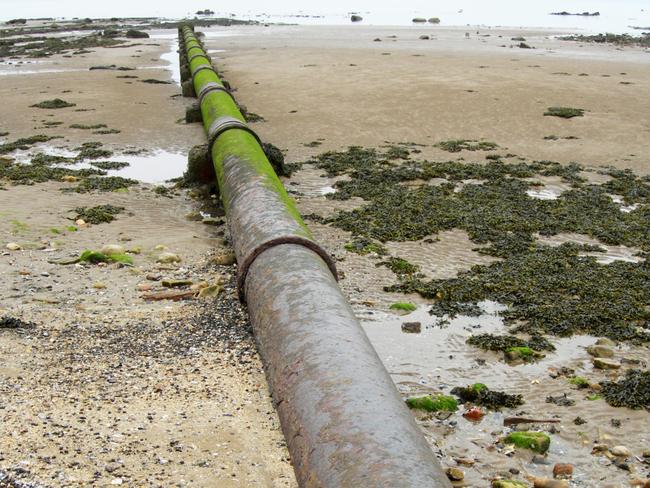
[0,25,295,487]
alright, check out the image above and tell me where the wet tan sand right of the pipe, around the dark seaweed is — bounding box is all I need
[201,26,650,487]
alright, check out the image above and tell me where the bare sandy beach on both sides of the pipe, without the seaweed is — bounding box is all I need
[0,18,650,487]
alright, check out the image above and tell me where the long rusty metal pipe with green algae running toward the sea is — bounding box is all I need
[183,27,451,488]
